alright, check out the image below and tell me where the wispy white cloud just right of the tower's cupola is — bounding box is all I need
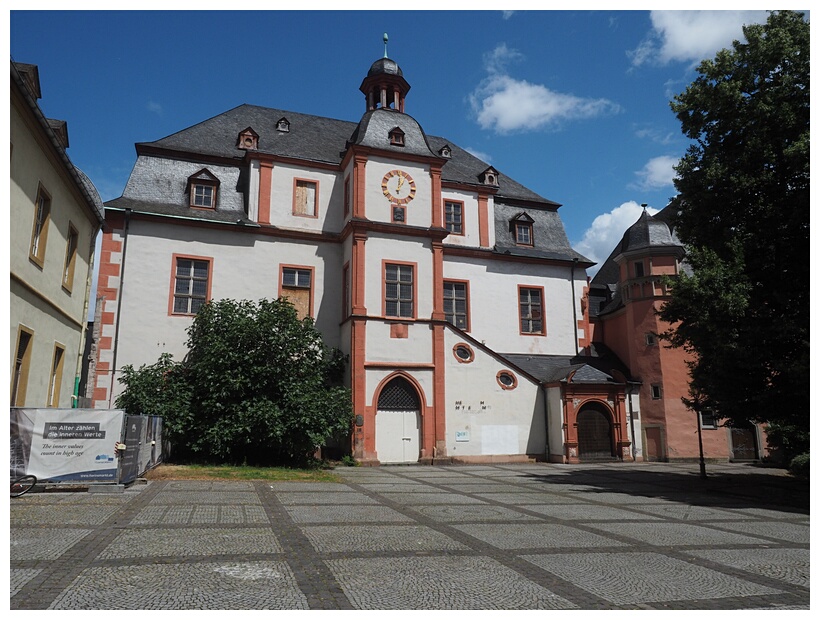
[468,44,621,134]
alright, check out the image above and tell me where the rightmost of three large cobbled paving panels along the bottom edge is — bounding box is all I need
[522,553,779,605]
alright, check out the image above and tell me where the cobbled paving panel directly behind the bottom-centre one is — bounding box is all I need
[302,525,467,553]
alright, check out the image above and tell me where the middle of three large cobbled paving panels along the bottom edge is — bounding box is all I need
[326,557,577,610]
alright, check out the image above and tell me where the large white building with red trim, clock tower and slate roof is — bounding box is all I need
[88,50,764,465]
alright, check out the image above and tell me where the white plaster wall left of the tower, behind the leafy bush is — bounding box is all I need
[103,220,341,395]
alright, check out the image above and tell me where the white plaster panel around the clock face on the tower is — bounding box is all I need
[365,157,433,228]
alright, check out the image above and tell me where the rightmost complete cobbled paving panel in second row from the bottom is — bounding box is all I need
[589,523,766,546]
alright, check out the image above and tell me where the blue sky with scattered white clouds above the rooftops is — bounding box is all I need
[8,2,780,275]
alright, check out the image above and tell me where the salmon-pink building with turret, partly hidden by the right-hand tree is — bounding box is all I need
[589,206,764,461]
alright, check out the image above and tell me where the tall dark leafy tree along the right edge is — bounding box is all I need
[661,11,810,456]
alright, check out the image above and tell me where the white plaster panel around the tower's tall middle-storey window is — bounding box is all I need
[364,233,433,319]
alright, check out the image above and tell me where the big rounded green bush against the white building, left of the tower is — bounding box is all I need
[117,299,352,465]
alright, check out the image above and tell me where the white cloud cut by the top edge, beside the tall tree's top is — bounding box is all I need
[629,11,768,67]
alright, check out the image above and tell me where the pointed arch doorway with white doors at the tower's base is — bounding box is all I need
[376,376,421,464]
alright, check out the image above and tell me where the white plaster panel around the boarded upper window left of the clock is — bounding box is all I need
[266,163,344,232]
